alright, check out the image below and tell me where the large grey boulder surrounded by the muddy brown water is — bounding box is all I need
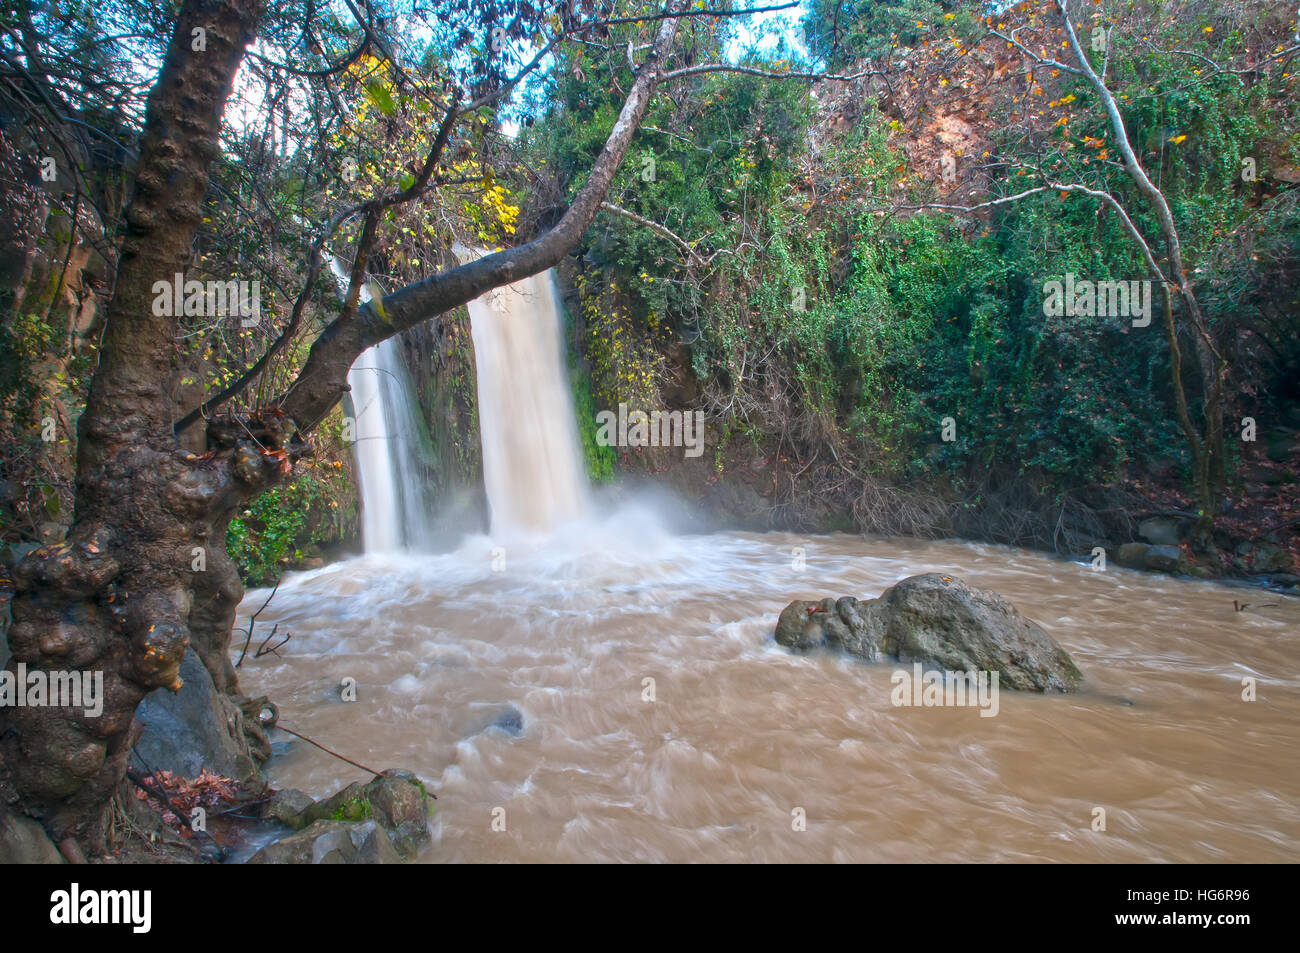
[776,572,1083,692]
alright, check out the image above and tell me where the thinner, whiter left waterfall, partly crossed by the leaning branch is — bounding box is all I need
[330,257,433,553]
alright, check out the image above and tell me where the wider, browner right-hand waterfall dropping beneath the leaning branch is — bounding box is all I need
[458,260,586,533]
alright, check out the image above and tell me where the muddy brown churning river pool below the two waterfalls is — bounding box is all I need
[239,520,1300,862]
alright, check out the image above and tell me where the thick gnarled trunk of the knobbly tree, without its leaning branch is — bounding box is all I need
[0,0,266,853]
